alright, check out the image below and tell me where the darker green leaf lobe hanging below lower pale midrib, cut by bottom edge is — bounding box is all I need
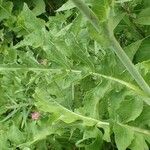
[113,124,134,150]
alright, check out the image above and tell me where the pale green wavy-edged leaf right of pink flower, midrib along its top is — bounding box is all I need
[34,84,107,126]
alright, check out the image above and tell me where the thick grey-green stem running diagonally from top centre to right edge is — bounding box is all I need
[71,0,150,96]
